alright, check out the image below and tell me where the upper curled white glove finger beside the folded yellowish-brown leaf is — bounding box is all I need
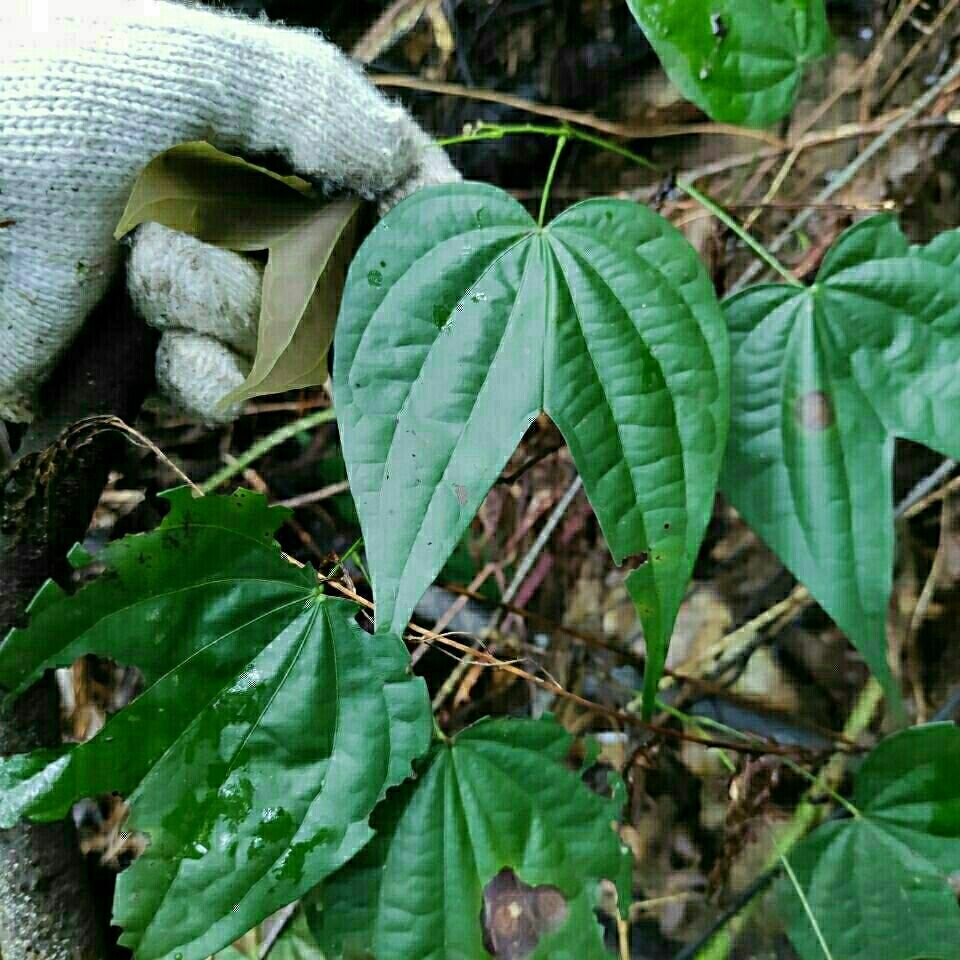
[127,223,264,357]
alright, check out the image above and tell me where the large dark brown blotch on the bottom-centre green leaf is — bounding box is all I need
[480,867,569,960]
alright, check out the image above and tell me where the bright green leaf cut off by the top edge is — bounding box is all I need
[627,0,831,127]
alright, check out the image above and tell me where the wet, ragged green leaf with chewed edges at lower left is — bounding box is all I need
[0,489,431,960]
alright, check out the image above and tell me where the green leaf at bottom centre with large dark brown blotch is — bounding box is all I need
[308,719,631,960]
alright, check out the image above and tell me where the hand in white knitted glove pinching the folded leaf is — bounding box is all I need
[0,0,459,419]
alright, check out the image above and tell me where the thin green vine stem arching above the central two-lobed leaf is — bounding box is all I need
[437,123,803,287]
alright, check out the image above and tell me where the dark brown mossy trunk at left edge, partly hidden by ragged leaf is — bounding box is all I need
[0,287,154,960]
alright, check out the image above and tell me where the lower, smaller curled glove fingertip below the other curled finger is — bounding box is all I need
[156,330,250,423]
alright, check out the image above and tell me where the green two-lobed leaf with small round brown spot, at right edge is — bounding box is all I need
[722,215,960,702]
